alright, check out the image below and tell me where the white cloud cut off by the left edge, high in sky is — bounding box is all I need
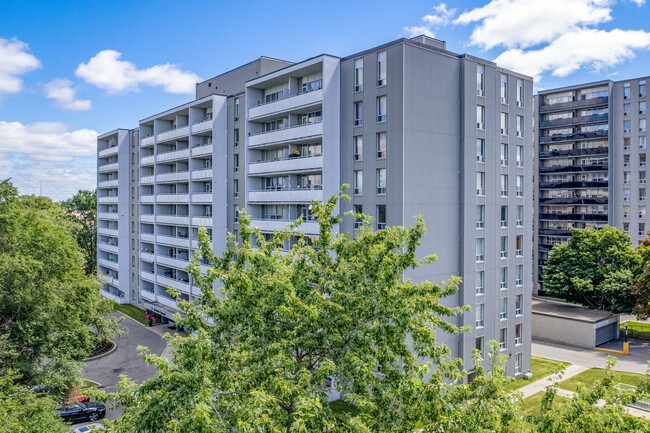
[0,38,41,93]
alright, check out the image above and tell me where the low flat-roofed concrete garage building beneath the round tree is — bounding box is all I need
[532,299,620,349]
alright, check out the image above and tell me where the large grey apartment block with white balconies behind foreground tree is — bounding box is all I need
[96,36,534,375]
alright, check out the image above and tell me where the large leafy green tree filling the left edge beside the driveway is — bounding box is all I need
[0,181,120,393]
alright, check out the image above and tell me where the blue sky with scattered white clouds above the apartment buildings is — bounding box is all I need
[0,0,650,200]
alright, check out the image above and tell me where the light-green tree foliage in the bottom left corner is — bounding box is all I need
[0,371,70,433]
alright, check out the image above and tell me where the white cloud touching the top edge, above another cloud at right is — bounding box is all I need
[454,0,612,49]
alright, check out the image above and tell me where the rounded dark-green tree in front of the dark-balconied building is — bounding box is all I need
[543,226,640,313]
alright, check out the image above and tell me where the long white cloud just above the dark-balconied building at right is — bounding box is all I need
[495,29,650,78]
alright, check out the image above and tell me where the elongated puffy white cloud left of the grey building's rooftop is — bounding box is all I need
[75,50,200,93]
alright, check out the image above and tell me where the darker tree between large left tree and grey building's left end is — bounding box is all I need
[61,189,97,275]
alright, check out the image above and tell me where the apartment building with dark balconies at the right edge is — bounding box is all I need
[535,78,650,289]
